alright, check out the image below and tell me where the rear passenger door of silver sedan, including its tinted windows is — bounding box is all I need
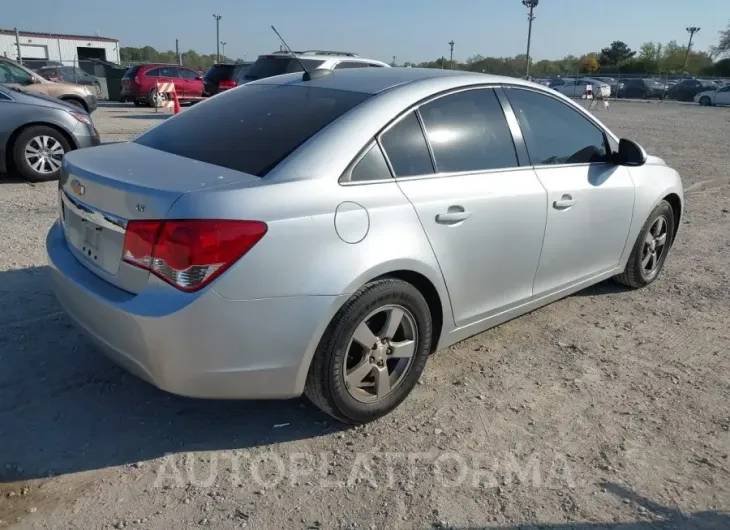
[380,88,546,327]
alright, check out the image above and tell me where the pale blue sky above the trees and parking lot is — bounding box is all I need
[0,0,730,64]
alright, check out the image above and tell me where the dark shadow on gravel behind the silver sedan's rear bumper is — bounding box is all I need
[0,267,345,484]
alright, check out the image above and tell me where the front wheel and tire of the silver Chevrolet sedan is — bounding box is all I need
[614,201,675,289]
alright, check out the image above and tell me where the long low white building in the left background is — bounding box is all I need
[0,29,119,65]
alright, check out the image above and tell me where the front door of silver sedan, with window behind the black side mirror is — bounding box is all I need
[505,87,634,297]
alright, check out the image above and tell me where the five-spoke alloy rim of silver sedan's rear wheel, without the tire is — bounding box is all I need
[342,305,418,403]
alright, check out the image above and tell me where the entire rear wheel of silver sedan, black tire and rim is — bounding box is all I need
[304,278,433,424]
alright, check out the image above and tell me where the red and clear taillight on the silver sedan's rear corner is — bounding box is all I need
[122,219,267,291]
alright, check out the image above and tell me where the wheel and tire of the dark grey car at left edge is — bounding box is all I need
[13,126,71,182]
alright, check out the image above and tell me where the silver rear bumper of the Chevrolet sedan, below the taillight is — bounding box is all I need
[46,223,338,399]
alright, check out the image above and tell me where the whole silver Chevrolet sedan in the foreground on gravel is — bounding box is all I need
[47,68,683,423]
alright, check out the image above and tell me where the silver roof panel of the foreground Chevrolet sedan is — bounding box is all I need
[251,67,534,94]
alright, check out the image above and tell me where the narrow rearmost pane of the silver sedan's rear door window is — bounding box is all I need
[380,112,433,177]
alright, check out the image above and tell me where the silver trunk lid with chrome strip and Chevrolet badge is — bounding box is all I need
[59,143,260,293]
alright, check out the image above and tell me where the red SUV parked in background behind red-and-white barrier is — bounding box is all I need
[120,64,203,106]
